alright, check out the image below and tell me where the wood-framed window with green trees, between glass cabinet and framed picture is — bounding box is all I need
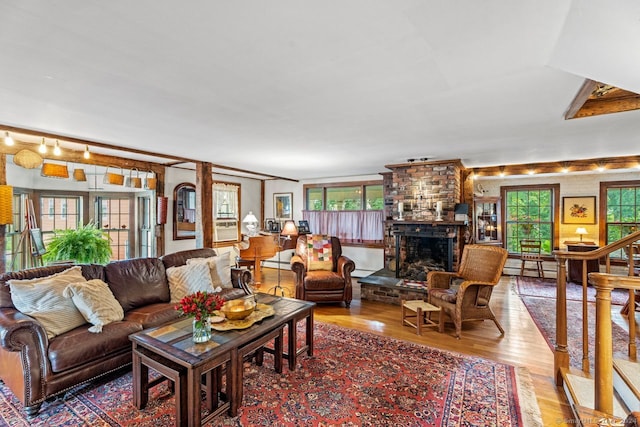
[501,184,560,255]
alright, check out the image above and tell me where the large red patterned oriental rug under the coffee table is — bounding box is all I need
[0,322,541,426]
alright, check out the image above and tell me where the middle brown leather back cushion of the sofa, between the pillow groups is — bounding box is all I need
[105,258,170,313]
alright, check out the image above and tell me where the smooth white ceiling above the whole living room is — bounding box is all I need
[0,0,640,179]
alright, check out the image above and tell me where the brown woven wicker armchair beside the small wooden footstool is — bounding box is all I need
[427,245,507,338]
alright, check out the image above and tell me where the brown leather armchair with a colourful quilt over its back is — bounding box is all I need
[291,235,356,308]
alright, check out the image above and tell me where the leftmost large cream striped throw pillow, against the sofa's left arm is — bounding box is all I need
[9,266,87,338]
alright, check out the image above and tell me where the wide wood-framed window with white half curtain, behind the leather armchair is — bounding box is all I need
[302,181,384,244]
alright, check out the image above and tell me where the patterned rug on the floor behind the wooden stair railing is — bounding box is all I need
[515,277,640,369]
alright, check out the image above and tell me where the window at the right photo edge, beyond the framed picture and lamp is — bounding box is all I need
[600,181,640,258]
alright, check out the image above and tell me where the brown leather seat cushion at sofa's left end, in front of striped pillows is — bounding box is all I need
[48,321,142,372]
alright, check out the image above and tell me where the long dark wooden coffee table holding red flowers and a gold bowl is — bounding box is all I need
[129,294,315,426]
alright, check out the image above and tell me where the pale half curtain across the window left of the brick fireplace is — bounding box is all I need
[302,210,384,242]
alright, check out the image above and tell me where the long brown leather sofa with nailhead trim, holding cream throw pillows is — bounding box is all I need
[0,248,251,416]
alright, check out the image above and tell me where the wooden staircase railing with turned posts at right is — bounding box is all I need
[553,231,640,414]
